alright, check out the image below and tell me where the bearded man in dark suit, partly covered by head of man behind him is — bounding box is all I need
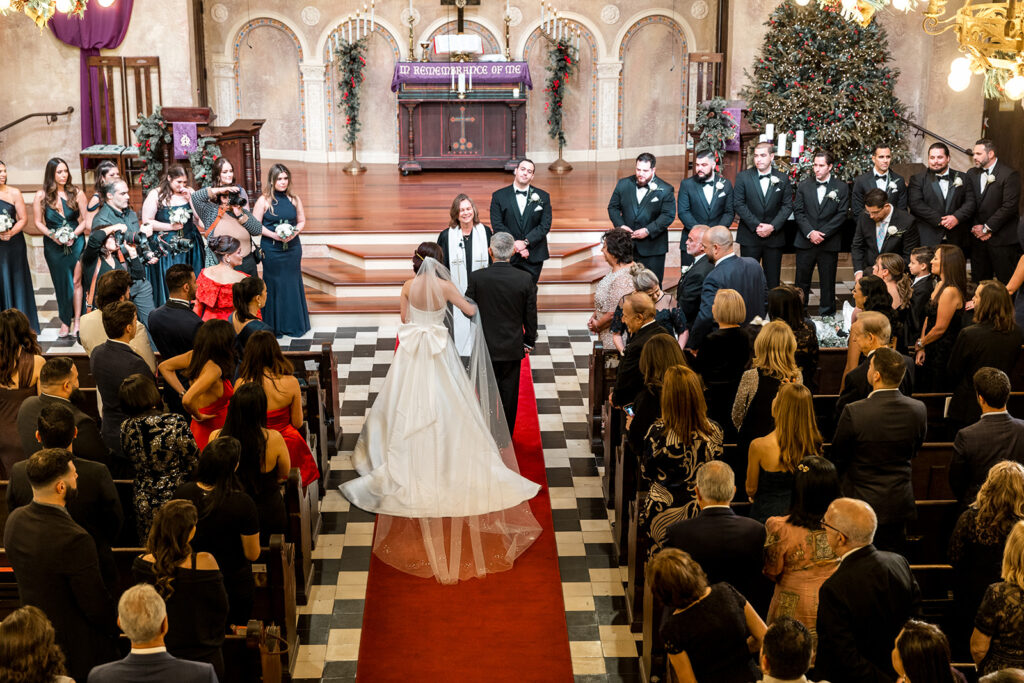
[17,356,111,464]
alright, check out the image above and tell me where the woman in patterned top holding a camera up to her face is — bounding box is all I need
[193,157,263,276]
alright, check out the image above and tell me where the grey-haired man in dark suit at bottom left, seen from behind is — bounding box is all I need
[87,584,217,683]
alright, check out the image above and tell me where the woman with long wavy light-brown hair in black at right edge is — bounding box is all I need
[949,462,1024,663]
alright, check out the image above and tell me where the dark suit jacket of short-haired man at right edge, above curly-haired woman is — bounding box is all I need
[949,413,1024,505]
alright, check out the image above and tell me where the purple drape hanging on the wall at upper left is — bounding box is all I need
[49,0,133,150]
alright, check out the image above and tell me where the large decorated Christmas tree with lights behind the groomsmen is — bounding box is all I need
[742,1,906,180]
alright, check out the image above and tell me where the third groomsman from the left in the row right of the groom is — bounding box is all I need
[732,142,793,289]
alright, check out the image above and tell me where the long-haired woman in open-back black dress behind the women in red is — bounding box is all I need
[210,382,292,546]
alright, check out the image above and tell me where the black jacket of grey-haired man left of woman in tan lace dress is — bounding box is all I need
[666,507,771,613]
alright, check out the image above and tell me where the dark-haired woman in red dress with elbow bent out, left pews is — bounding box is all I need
[159,319,234,451]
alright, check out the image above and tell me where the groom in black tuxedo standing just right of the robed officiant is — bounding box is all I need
[490,159,551,285]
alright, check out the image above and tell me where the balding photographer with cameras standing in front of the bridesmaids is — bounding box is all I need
[86,179,154,326]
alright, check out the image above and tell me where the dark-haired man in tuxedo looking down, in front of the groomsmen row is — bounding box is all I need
[850,188,921,280]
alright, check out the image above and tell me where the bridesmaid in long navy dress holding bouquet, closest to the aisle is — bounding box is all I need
[253,164,309,337]
